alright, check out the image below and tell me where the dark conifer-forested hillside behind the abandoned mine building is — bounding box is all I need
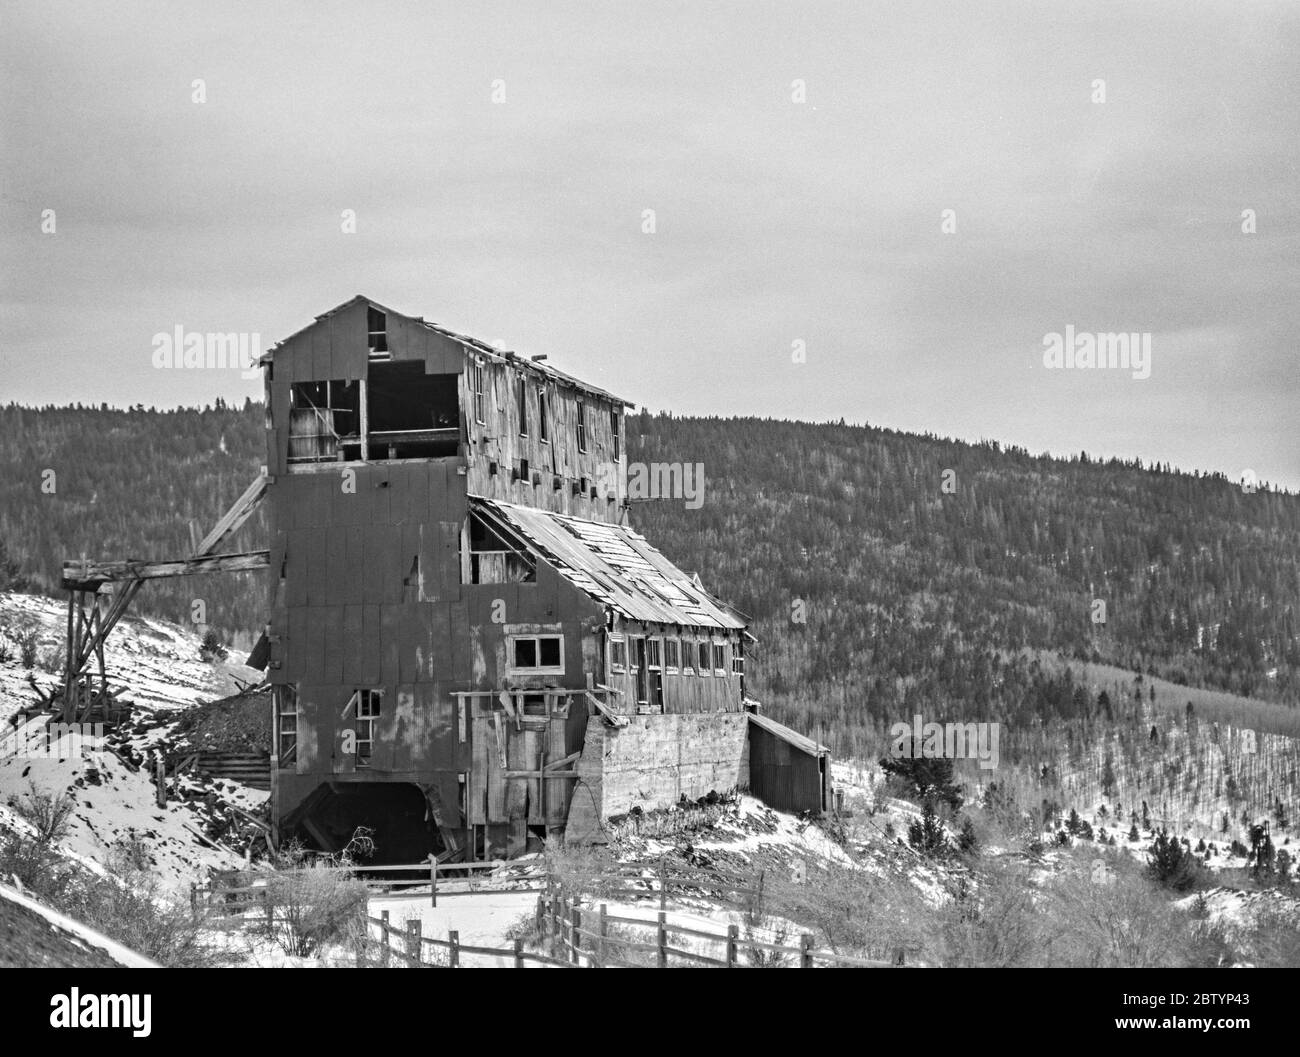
[0,403,1300,749]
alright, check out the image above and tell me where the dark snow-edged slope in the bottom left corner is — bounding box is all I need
[0,884,159,969]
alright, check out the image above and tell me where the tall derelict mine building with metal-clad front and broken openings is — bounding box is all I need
[65,296,831,862]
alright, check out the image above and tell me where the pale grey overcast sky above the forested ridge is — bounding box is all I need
[0,0,1300,489]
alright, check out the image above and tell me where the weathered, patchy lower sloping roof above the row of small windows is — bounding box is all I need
[469,495,748,629]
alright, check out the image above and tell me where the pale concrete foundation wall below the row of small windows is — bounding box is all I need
[564,712,749,842]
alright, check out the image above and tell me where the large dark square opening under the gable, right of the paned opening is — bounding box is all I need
[365,360,460,460]
